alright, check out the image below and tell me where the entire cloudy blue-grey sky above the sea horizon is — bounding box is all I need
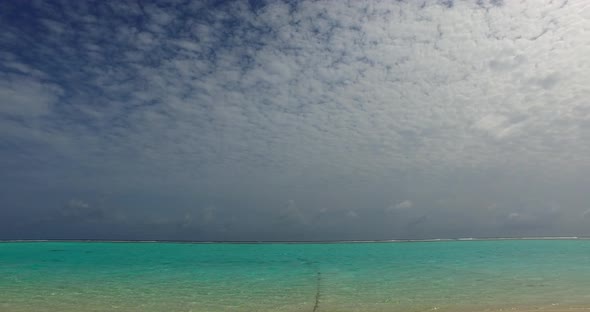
[0,0,590,241]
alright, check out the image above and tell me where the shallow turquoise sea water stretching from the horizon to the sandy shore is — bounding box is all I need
[0,240,590,312]
